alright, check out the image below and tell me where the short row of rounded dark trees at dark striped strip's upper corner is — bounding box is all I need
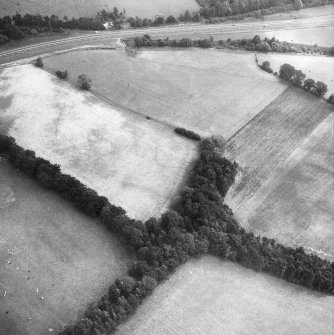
[279,63,328,97]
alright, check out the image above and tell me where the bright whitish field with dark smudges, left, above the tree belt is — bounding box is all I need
[0,65,197,219]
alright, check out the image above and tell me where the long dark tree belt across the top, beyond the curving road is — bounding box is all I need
[0,0,334,44]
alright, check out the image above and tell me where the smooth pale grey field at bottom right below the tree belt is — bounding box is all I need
[116,257,334,335]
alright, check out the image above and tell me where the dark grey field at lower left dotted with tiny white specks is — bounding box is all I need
[0,160,132,335]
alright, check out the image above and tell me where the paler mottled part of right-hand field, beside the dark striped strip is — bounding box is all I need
[248,113,334,260]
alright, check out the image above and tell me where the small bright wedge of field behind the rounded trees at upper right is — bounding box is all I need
[259,53,334,97]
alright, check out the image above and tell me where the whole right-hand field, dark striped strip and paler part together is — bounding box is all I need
[225,88,334,259]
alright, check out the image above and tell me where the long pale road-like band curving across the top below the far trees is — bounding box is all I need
[0,15,334,64]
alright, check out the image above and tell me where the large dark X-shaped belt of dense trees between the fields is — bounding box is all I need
[0,136,334,335]
